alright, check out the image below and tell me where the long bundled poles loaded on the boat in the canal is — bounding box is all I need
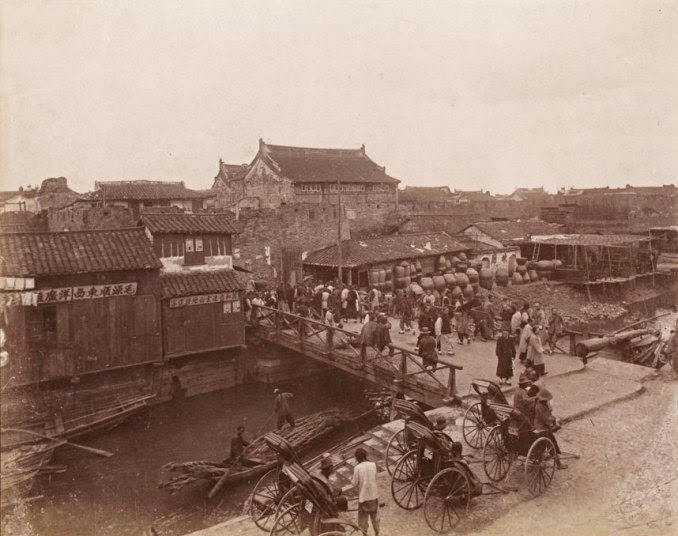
[158,410,347,493]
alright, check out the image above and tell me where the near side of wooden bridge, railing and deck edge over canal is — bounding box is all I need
[250,306,463,407]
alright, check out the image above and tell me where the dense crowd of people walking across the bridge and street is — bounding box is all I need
[244,278,564,385]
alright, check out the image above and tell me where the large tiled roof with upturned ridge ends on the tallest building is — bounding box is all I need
[258,141,400,184]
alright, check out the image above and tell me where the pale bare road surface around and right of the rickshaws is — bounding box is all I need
[187,360,678,536]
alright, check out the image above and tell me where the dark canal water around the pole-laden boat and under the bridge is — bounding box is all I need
[11,371,382,536]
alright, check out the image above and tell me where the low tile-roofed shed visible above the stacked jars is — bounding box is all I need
[303,233,471,288]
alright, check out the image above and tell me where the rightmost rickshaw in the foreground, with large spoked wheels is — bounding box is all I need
[483,404,578,496]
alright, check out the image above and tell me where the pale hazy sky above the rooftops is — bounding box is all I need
[0,0,678,192]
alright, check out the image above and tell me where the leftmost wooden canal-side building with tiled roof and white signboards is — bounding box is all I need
[0,228,162,386]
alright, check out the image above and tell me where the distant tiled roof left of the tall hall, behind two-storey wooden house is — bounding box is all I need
[93,180,214,200]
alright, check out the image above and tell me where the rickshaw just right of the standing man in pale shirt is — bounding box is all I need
[391,422,508,532]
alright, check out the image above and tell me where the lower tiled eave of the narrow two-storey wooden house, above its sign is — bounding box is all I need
[160,270,245,298]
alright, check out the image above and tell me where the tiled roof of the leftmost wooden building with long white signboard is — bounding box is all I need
[0,227,161,277]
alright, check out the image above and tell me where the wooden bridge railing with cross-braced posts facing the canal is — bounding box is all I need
[250,305,463,400]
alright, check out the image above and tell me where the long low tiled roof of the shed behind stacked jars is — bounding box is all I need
[304,233,469,267]
